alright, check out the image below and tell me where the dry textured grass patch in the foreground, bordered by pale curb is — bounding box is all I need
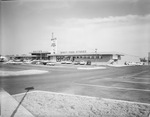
[13,91,150,117]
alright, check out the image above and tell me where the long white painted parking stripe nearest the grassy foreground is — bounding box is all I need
[74,83,150,92]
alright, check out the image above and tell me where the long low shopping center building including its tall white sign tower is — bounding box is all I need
[12,33,140,65]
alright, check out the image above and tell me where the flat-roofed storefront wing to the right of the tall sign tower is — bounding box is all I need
[48,52,123,65]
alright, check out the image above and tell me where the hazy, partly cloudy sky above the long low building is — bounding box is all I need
[0,0,150,57]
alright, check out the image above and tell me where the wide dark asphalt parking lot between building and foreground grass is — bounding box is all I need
[0,64,150,103]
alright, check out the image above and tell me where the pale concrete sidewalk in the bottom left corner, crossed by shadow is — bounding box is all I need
[0,90,34,117]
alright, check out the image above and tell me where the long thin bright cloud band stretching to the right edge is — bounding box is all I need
[63,14,150,27]
